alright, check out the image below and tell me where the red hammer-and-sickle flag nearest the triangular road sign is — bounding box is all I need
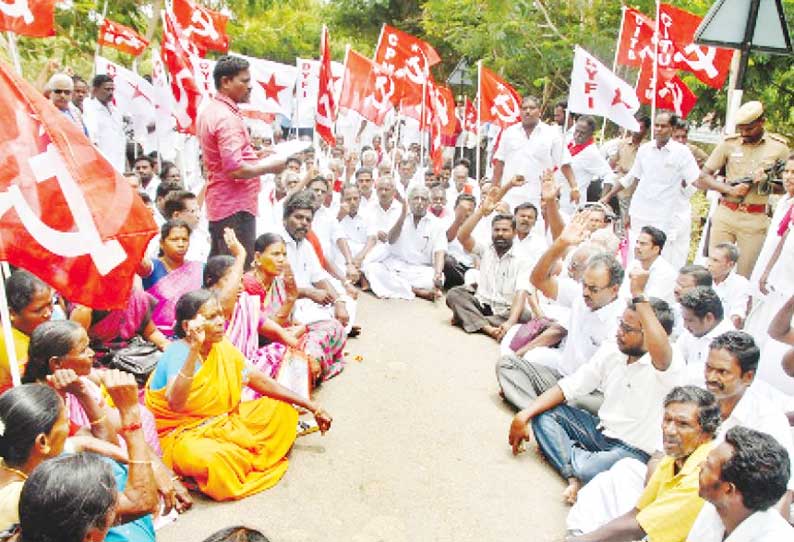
[659,4,733,89]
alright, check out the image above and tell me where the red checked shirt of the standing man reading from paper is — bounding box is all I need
[196,94,260,222]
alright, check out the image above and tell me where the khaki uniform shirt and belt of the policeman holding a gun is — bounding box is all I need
[705,132,789,204]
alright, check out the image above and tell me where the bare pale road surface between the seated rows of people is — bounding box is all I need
[158,295,566,542]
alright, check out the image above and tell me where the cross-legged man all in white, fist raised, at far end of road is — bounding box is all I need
[363,185,447,300]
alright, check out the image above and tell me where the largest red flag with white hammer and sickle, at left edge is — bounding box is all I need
[0,64,157,309]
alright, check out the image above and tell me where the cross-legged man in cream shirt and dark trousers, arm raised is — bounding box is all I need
[447,188,531,341]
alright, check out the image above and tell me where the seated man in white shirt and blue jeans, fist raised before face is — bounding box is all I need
[509,276,685,504]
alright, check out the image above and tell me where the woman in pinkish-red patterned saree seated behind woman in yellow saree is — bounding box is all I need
[243,233,346,383]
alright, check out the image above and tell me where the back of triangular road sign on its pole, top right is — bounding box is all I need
[695,0,794,133]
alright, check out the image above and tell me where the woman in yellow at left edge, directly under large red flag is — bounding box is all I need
[0,269,52,393]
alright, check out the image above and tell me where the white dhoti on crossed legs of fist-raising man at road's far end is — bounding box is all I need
[364,256,435,299]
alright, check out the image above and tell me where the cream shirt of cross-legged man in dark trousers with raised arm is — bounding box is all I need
[473,243,531,314]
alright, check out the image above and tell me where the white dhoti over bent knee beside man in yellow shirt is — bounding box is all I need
[566,457,648,533]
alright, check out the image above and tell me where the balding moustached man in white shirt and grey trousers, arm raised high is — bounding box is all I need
[496,213,625,412]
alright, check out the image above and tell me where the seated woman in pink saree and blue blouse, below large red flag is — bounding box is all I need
[138,220,204,337]
